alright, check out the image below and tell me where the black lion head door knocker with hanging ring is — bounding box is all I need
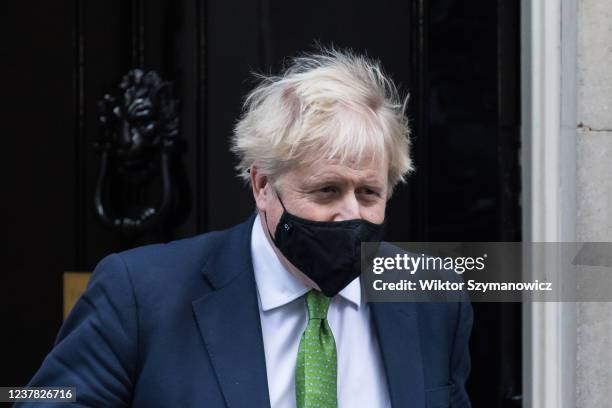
[94,69,180,233]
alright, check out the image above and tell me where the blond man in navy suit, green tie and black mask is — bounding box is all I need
[19,49,472,408]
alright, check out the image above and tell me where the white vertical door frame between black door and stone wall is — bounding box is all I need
[521,0,578,408]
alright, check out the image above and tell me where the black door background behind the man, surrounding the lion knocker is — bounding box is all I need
[0,0,521,407]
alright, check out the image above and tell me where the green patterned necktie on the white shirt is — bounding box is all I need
[295,290,338,408]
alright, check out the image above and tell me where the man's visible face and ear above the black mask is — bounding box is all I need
[251,156,388,287]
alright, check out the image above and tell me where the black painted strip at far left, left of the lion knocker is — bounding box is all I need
[0,1,78,386]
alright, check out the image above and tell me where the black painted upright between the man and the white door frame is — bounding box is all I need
[422,0,521,407]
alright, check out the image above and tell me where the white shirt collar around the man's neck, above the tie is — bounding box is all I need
[251,214,361,311]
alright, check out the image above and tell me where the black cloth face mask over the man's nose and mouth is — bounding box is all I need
[264,193,384,297]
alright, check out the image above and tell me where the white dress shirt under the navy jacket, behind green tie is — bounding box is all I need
[251,216,391,408]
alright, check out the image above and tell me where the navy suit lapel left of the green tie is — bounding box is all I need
[193,217,270,408]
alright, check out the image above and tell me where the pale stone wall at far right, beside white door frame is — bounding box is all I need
[576,0,612,408]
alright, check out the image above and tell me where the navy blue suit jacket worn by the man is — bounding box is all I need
[24,217,472,408]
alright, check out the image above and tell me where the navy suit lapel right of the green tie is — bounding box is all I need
[370,302,425,408]
